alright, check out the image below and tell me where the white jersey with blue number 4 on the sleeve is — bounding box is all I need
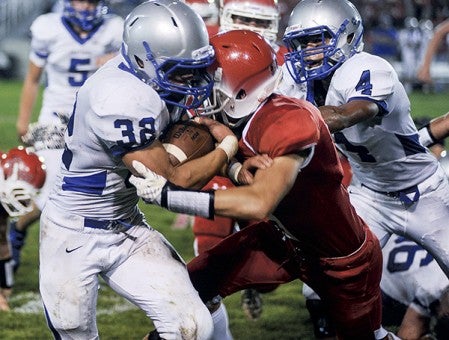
[279,52,438,192]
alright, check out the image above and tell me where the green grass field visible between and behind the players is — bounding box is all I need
[0,81,449,340]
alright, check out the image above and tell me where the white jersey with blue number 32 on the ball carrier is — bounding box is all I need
[49,54,170,220]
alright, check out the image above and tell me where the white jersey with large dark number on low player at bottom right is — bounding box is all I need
[380,236,449,317]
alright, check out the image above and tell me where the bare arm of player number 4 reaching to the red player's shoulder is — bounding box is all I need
[318,100,379,133]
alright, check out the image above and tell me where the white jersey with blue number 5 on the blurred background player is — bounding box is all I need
[30,13,123,123]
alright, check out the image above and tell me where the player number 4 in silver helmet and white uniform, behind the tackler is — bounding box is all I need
[279,0,449,338]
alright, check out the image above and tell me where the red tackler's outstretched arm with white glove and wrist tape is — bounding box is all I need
[130,151,308,219]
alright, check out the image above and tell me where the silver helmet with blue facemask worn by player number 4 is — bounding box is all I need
[283,0,363,83]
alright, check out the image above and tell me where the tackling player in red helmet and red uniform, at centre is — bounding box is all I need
[130,31,389,339]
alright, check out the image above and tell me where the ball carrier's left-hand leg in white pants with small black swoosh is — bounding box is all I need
[39,207,101,339]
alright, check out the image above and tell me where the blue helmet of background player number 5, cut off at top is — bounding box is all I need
[62,0,107,32]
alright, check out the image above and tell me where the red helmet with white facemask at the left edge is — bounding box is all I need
[0,146,46,217]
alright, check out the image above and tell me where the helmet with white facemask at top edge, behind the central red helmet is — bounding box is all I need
[220,0,280,44]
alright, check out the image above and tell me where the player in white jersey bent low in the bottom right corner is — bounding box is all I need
[381,235,449,339]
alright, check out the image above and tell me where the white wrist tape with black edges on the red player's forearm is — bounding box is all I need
[161,182,215,219]
